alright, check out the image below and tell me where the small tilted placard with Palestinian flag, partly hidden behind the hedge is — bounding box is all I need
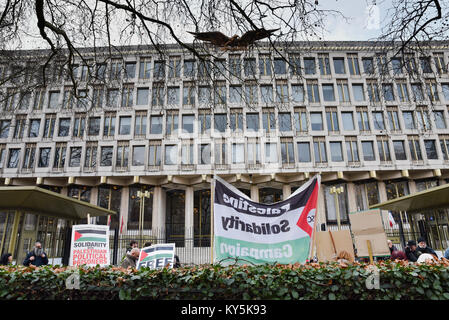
[137,243,175,269]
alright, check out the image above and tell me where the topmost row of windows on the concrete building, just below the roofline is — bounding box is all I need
[0,53,447,82]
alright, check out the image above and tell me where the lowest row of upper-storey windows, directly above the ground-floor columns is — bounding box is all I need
[0,136,449,169]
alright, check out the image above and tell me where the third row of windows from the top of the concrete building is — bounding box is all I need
[0,107,448,139]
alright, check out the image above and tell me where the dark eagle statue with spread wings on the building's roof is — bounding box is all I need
[188,28,279,50]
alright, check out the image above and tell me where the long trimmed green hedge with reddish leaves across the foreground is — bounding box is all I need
[0,261,449,300]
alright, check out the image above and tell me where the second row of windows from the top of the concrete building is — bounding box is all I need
[3,80,449,110]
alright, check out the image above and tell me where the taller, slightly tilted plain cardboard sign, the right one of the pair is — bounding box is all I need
[349,209,390,257]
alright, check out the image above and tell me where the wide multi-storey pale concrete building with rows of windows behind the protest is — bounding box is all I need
[0,42,449,261]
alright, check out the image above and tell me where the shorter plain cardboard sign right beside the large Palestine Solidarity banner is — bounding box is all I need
[315,230,354,262]
